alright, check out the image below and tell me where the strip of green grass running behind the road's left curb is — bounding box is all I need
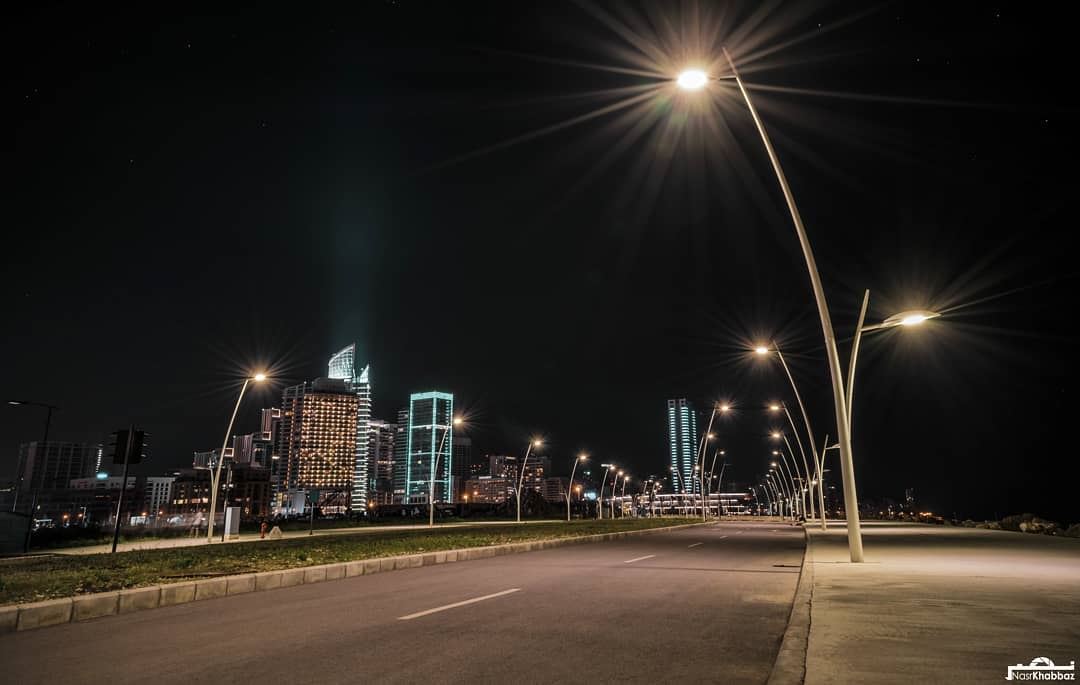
[0,519,697,605]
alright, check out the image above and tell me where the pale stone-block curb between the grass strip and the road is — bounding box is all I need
[0,523,708,630]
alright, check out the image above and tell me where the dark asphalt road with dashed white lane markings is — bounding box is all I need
[0,523,804,685]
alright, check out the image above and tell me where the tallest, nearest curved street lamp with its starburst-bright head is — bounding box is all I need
[678,48,863,562]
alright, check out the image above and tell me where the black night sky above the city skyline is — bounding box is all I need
[10,0,1080,522]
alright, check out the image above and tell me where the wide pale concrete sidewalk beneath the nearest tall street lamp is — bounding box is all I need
[806,522,1080,683]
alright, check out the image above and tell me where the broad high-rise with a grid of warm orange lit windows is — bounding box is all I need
[278,378,367,492]
